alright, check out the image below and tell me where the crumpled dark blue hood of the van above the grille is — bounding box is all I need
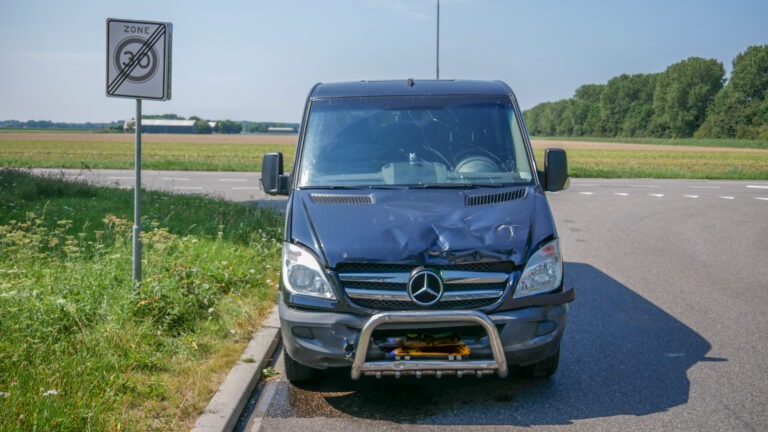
[290,187,554,268]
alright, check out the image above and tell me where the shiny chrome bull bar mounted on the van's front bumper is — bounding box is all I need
[350,310,507,380]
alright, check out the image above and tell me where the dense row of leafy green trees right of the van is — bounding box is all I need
[523,45,768,140]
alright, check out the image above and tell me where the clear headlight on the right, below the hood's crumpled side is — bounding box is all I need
[514,239,563,298]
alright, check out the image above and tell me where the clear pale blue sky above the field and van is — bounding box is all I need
[0,0,768,122]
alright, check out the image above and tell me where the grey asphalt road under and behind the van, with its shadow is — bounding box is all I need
[30,170,768,432]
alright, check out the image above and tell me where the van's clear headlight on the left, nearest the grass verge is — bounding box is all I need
[283,243,336,300]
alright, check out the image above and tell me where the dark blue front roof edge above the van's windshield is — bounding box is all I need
[309,79,511,99]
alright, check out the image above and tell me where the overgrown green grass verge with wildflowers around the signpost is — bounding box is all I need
[0,169,282,430]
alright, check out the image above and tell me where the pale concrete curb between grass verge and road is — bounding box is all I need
[192,306,280,432]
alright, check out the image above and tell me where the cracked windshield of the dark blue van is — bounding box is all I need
[298,96,533,188]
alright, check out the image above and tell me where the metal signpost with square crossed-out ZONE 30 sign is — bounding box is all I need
[107,18,172,282]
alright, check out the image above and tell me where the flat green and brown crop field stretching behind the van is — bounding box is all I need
[0,132,768,179]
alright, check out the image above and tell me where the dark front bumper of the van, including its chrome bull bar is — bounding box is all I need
[279,289,573,379]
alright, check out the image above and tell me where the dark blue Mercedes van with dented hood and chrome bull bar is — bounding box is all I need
[261,80,574,382]
